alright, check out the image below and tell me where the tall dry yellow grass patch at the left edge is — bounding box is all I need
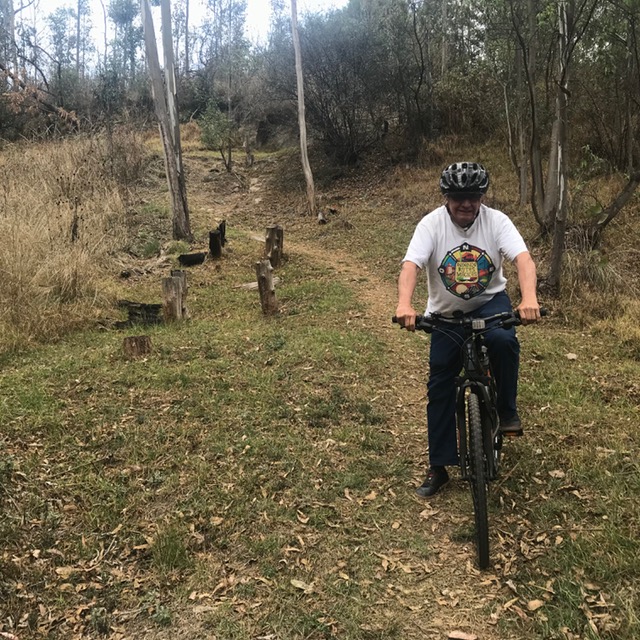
[0,137,141,349]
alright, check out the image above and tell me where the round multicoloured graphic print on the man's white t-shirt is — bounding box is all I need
[438,244,496,300]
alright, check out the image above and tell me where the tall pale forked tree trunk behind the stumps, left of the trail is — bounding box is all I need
[140,0,193,241]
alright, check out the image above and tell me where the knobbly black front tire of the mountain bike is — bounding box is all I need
[467,393,489,569]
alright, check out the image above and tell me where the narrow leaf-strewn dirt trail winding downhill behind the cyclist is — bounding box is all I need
[182,155,518,640]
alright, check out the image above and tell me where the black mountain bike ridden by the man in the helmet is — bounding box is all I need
[393,309,546,569]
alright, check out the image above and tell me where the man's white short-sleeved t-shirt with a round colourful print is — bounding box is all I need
[403,205,527,315]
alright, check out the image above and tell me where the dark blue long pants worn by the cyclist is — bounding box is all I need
[427,292,520,466]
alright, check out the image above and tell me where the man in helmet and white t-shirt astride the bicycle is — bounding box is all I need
[395,162,540,497]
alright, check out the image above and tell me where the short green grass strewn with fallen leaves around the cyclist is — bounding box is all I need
[0,140,640,640]
